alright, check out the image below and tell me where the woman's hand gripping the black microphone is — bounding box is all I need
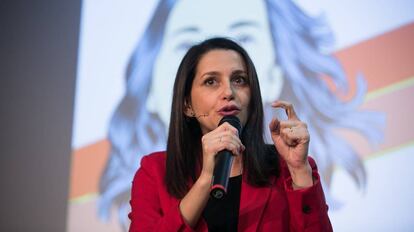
[201,122,245,176]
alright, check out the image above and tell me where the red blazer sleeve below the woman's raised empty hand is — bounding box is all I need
[282,157,333,232]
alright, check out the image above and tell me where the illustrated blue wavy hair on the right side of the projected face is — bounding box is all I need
[265,0,385,207]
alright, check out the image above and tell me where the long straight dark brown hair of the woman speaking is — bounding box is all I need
[165,38,279,199]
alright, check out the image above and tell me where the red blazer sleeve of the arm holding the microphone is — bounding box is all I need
[128,156,194,232]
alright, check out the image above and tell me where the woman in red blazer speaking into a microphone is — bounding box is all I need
[129,38,332,231]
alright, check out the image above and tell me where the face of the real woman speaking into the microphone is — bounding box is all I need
[184,49,250,134]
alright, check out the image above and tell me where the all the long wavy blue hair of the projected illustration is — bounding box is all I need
[98,0,385,228]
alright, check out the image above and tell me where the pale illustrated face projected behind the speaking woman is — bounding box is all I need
[146,0,283,128]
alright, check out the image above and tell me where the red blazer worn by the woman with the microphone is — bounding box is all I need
[128,152,332,232]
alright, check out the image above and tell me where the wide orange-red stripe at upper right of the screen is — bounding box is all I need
[335,23,414,94]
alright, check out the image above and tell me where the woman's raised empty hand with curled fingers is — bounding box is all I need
[269,101,313,189]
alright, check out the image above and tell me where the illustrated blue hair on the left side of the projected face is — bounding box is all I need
[98,1,175,226]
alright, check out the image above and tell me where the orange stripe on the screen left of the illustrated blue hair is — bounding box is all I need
[69,139,110,199]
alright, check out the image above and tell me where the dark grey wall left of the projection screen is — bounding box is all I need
[0,0,81,231]
